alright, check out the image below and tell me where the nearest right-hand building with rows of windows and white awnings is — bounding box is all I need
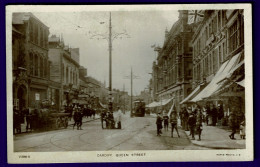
[186,10,245,116]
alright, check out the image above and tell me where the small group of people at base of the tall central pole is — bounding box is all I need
[100,107,122,129]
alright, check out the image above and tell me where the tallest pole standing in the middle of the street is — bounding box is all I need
[108,12,113,111]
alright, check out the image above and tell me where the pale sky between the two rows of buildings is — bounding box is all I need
[33,10,178,95]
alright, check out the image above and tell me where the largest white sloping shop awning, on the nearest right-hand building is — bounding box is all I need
[191,52,241,102]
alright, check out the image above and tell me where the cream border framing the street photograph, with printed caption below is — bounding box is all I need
[6,4,253,163]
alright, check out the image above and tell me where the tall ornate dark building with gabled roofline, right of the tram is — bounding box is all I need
[153,10,194,110]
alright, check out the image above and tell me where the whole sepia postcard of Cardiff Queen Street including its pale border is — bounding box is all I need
[6,4,253,163]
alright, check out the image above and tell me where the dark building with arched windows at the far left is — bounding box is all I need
[12,13,50,109]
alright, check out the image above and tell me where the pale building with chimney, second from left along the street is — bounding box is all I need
[48,35,80,109]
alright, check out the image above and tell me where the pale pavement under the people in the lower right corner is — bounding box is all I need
[185,125,246,149]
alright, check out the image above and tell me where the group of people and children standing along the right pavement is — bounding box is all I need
[156,104,245,141]
